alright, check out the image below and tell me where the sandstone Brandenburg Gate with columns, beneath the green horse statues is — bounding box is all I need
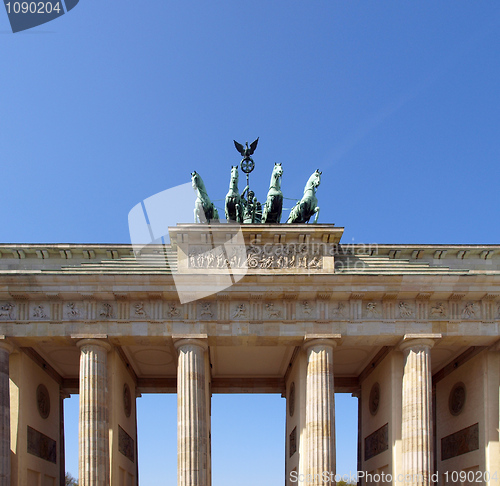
[0,223,500,486]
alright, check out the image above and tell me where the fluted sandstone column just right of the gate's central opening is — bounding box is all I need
[304,339,336,486]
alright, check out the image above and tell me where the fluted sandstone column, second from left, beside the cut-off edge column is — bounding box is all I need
[77,339,111,486]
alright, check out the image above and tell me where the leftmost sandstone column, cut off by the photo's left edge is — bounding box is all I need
[0,342,12,486]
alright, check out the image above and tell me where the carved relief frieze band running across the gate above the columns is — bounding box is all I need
[0,294,492,322]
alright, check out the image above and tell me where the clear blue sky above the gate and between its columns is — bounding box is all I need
[0,0,500,486]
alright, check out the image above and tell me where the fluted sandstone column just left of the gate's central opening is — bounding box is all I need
[174,339,210,486]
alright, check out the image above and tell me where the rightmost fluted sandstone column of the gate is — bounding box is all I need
[400,339,434,486]
